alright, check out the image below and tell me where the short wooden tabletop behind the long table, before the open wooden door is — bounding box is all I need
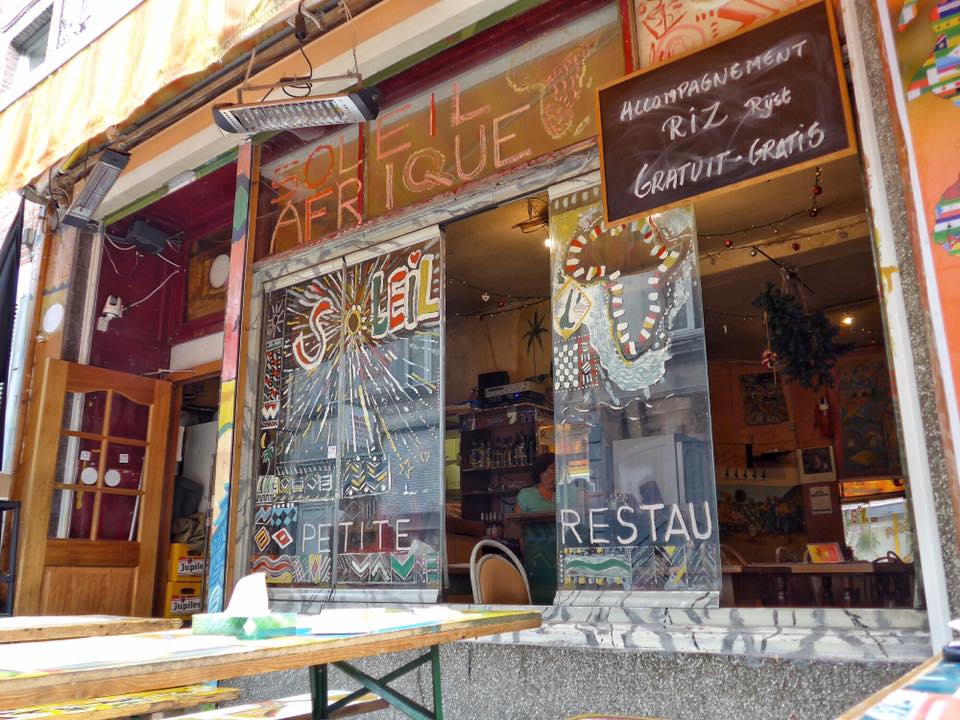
[0,615,183,643]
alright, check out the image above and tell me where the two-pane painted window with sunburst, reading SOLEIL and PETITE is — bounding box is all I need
[251,240,443,587]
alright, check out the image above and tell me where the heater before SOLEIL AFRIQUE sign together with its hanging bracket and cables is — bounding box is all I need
[213,11,380,134]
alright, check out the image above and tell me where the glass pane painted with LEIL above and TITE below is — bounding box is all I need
[337,239,444,588]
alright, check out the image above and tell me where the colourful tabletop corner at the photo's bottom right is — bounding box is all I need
[837,654,960,720]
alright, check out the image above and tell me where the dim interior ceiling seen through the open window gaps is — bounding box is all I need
[445,156,883,361]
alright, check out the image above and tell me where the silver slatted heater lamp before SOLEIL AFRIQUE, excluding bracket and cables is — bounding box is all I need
[213,87,380,133]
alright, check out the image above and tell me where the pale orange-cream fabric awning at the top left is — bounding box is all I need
[0,0,297,195]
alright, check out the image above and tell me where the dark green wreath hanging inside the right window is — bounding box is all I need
[753,284,853,390]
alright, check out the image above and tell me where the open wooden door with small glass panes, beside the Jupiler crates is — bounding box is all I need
[16,359,171,616]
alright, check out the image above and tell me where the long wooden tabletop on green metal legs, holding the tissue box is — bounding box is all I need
[0,611,540,710]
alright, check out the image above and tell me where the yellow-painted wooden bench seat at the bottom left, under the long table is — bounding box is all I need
[0,685,240,720]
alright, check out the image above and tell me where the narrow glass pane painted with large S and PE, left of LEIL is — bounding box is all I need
[251,270,343,586]
